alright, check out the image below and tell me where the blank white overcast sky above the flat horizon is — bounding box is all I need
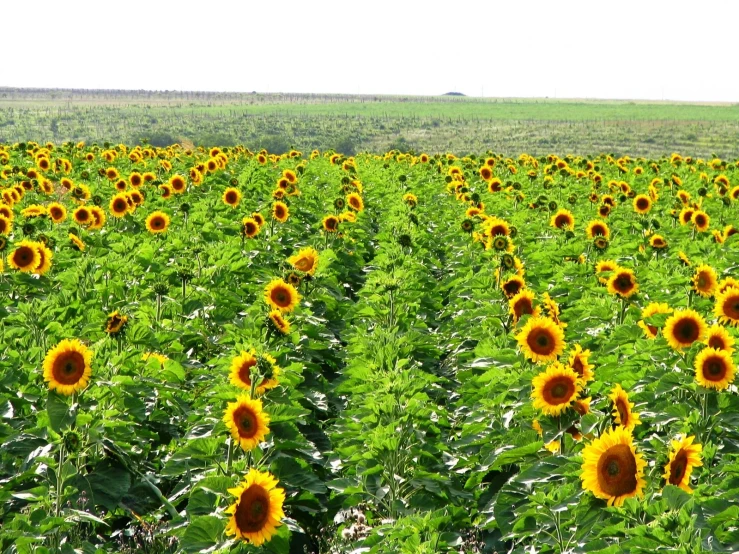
[0,0,739,102]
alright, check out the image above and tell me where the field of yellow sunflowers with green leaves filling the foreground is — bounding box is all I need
[0,142,739,554]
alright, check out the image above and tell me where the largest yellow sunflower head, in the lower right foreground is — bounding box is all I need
[580,426,647,506]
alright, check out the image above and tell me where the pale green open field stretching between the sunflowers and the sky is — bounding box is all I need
[0,89,739,157]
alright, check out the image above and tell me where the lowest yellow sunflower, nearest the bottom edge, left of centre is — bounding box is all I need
[226,468,285,546]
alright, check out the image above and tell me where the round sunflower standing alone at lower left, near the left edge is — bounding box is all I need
[43,339,92,396]
